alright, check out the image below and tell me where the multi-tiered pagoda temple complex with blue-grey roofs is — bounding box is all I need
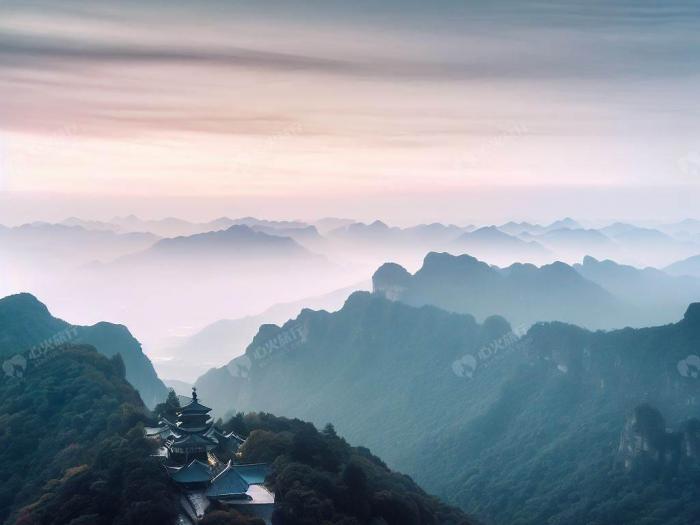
[145,388,275,524]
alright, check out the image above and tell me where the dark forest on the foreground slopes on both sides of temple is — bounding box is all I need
[0,346,471,525]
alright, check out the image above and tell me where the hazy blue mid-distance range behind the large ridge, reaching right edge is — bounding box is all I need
[373,251,700,329]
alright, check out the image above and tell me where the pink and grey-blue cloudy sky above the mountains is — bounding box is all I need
[0,0,700,224]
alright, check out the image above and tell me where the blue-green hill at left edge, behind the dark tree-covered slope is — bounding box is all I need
[0,294,168,406]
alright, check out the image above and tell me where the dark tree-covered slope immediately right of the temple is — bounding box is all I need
[232,414,470,525]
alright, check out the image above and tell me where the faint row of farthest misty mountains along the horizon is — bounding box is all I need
[0,215,700,267]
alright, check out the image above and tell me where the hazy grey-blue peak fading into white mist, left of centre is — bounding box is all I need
[78,225,342,347]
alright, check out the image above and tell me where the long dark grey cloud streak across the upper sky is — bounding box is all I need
[0,21,698,81]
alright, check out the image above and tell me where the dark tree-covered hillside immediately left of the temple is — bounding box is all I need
[0,346,175,525]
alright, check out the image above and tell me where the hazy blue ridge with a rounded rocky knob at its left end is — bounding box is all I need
[372,253,631,328]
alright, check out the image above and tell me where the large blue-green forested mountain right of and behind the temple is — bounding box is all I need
[197,290,700,525]
